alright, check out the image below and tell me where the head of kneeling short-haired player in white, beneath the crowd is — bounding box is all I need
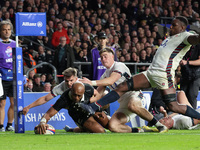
[99,47,115,68]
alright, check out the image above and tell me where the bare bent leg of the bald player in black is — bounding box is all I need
[83,116,105,133]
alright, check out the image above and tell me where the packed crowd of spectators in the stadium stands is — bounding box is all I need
[0,0,200,92]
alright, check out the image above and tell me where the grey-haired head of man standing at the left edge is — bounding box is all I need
[0,21,13,40]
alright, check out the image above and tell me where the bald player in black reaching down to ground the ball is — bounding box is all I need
[37,82,108,134]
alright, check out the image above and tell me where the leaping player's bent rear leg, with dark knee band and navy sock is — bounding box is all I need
[161,88,200,119]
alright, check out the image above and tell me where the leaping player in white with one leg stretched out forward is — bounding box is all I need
[90,16,200,130]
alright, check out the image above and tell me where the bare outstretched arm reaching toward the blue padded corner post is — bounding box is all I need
[23,93,54,115]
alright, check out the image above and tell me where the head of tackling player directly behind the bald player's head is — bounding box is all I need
[62,67,78,88]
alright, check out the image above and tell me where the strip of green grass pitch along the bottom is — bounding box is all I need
[0,130,200,150]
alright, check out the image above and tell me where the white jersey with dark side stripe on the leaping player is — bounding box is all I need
[149,31,194,78]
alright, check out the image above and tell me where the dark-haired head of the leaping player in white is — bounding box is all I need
[170,16,188,36]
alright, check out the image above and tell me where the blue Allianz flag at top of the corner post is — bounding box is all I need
[15,12,46,36]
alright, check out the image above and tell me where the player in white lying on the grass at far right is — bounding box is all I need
[160,91,200,130]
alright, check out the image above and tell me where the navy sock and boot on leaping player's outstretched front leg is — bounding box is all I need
[89,91,120,111]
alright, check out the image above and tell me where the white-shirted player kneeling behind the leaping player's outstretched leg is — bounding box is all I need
[80,47,166,132]
